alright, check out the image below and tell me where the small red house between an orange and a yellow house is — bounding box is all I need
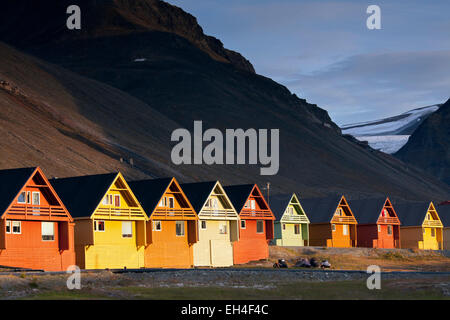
[349,198,400,249]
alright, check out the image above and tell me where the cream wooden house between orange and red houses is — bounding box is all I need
[181,181,239,267]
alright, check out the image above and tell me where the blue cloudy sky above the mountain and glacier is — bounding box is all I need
[167,0,450,125]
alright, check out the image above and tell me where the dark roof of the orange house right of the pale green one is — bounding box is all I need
[302,196,342,223]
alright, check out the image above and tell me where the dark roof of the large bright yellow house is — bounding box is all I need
[50,173,118,218]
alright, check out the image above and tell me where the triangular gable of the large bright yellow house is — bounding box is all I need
[90,172,147,220]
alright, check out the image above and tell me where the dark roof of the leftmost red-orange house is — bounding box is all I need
[0,167,37,216]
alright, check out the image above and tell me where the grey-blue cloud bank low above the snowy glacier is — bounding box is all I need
[281,50,450,124]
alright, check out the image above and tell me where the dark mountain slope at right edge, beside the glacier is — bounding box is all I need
[395,99,450,184]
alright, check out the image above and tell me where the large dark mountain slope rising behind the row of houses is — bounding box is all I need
[0,0,450,200]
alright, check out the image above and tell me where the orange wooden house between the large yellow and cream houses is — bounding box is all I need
[130,178,198,268]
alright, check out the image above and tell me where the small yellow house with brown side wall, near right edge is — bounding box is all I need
[395,202,443,250]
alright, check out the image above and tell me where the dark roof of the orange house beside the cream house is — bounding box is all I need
[128,178,173,217]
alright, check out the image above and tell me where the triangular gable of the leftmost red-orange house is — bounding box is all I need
[0,167,73,221]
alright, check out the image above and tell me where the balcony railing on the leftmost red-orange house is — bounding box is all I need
[8,204,67,220]
